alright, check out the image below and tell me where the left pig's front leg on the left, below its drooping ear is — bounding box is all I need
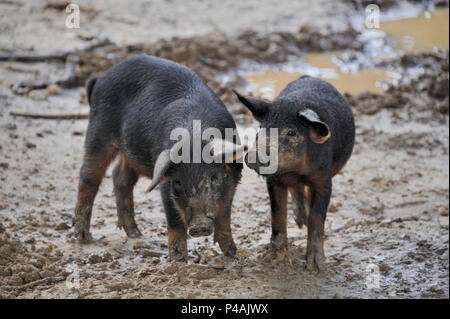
[160,183,188,262]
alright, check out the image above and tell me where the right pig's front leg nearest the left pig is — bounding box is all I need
[267,179,288,259]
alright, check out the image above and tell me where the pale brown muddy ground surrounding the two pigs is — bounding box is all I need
[0,0,449,298]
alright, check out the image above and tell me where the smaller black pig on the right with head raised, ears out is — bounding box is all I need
[235,76,355,270]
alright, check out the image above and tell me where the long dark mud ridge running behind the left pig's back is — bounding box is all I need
[0,26,362,112]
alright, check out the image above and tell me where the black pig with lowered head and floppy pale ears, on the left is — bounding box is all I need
[74,55,244,261]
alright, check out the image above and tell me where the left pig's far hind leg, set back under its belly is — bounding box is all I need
[113,158,141,238]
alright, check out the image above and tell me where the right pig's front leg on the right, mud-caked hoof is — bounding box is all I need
[306,180,332,271]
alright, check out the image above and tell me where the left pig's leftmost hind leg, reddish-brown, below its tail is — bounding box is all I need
[73,142,117,243]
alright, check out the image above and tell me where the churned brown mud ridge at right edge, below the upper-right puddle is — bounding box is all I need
[345,50,449,123]
